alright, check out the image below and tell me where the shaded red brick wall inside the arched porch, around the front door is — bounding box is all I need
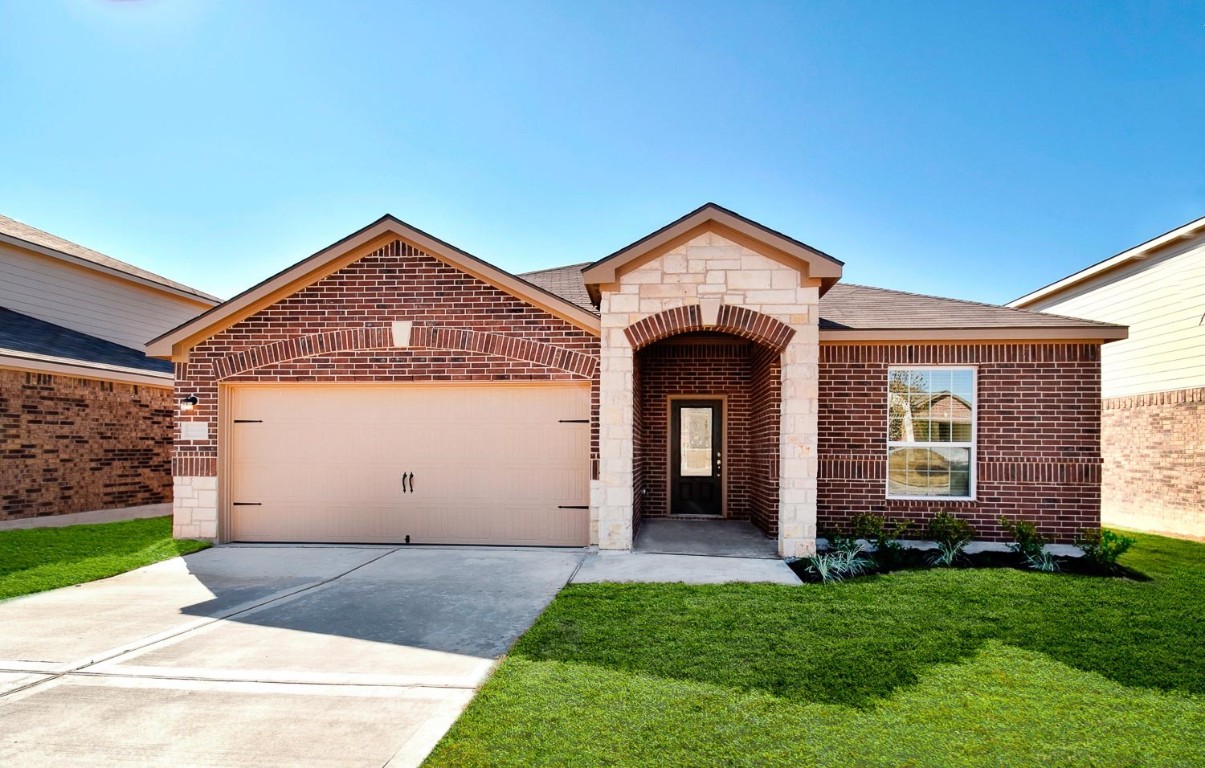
[633,334,780,535]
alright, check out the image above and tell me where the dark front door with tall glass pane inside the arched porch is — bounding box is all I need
[670,399,724,517]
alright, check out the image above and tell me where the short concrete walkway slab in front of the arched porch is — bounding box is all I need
[572,552,803,586]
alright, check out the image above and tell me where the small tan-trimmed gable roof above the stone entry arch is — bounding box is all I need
[583,203,845,301]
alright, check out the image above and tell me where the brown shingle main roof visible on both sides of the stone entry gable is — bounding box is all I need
[519,264,1110,330]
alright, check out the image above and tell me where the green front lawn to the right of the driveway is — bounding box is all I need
[428,535,1205,767]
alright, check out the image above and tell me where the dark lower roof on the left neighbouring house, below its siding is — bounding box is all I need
[0,307,172,376]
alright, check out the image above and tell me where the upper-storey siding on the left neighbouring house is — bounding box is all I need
[0,244,207,350]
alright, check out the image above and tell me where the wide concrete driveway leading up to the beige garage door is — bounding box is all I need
[0,546,584,767]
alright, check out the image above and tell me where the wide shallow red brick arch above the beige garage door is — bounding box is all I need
[213,326,596,380]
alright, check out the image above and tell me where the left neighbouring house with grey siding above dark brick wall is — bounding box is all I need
[0,216,218,520]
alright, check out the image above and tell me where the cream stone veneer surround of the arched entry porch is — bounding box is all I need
[590,233,819,557]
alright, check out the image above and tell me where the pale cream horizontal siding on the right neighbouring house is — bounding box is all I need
[1027,238,1205,398]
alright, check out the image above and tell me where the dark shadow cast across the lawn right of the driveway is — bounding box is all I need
[515,537,1205,707]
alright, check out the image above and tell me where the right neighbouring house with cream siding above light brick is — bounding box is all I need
[1010,218,1205,537]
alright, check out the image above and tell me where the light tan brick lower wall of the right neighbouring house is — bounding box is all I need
[1101,388,1205,538]
